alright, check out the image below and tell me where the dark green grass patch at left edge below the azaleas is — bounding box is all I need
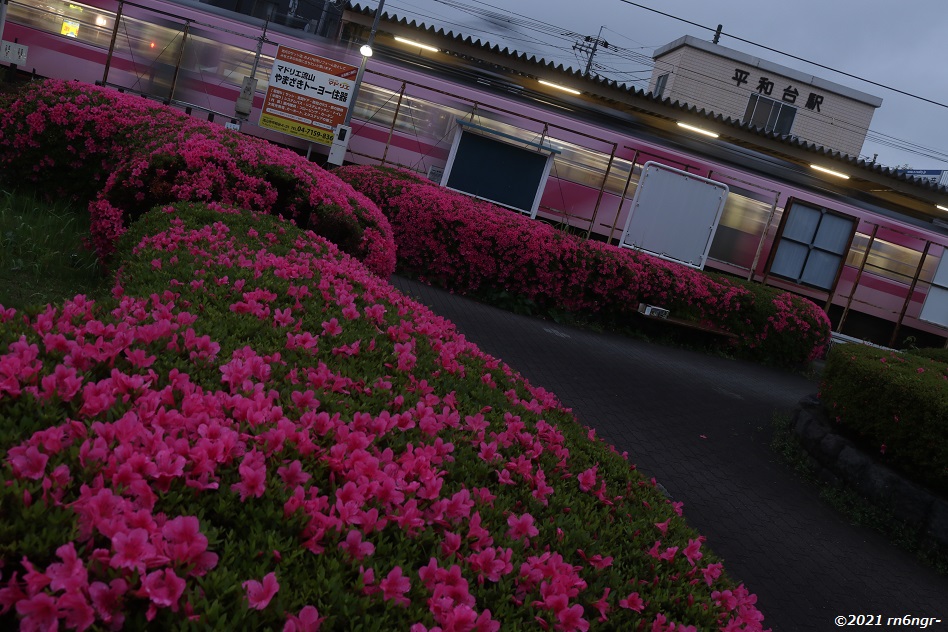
[0,189,110,310]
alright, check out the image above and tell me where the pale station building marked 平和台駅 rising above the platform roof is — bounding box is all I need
[649,35,882,156]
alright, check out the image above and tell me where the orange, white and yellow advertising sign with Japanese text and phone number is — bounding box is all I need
[258,46,359,145]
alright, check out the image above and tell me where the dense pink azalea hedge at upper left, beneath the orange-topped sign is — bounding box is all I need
[0,80,395,277]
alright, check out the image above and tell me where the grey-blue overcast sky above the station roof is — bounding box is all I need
[358,0,948,170]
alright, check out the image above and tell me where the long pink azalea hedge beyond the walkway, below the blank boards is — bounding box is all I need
[335,166,830,366]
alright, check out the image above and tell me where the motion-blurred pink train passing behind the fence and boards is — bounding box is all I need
[3,0,948,346]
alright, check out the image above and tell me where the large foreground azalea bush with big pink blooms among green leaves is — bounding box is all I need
[0,204,763,632]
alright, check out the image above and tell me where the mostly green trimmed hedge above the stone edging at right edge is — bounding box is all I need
[820,344,948,493]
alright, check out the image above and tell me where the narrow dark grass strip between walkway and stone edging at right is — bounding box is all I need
[770,413,948,575]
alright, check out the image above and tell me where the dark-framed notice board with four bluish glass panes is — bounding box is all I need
[770,202,856,290]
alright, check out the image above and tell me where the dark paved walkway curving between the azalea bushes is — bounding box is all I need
[392,277,948,632]
